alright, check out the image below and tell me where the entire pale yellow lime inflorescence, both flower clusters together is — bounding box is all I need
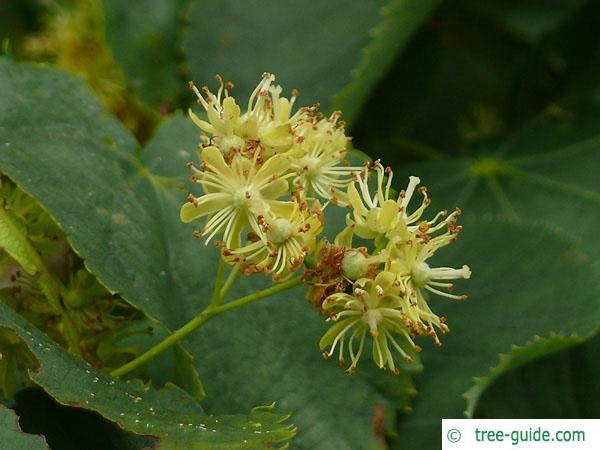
[181,74,471,373]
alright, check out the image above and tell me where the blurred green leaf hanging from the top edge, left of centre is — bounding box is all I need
[102,0,188,107]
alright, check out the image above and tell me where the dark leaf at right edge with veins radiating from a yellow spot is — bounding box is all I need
[397,91,600,260]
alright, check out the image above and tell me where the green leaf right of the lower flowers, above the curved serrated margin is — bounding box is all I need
[390,216,600,449]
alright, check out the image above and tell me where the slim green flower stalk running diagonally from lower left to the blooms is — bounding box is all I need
[111,277,302,377]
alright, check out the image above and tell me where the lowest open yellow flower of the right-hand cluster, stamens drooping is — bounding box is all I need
[319,271,420,374]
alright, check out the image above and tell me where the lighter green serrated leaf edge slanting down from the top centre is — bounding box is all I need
[334,0,440,123]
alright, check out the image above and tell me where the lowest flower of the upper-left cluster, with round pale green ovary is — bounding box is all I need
[224,202,323,280]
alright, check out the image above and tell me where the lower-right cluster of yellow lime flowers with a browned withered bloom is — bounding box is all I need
[308,161,471,373]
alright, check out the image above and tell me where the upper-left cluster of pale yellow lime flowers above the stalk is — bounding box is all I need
[181,73,360,280]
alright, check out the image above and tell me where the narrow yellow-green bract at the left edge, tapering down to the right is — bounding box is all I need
[0,204,82,356]
